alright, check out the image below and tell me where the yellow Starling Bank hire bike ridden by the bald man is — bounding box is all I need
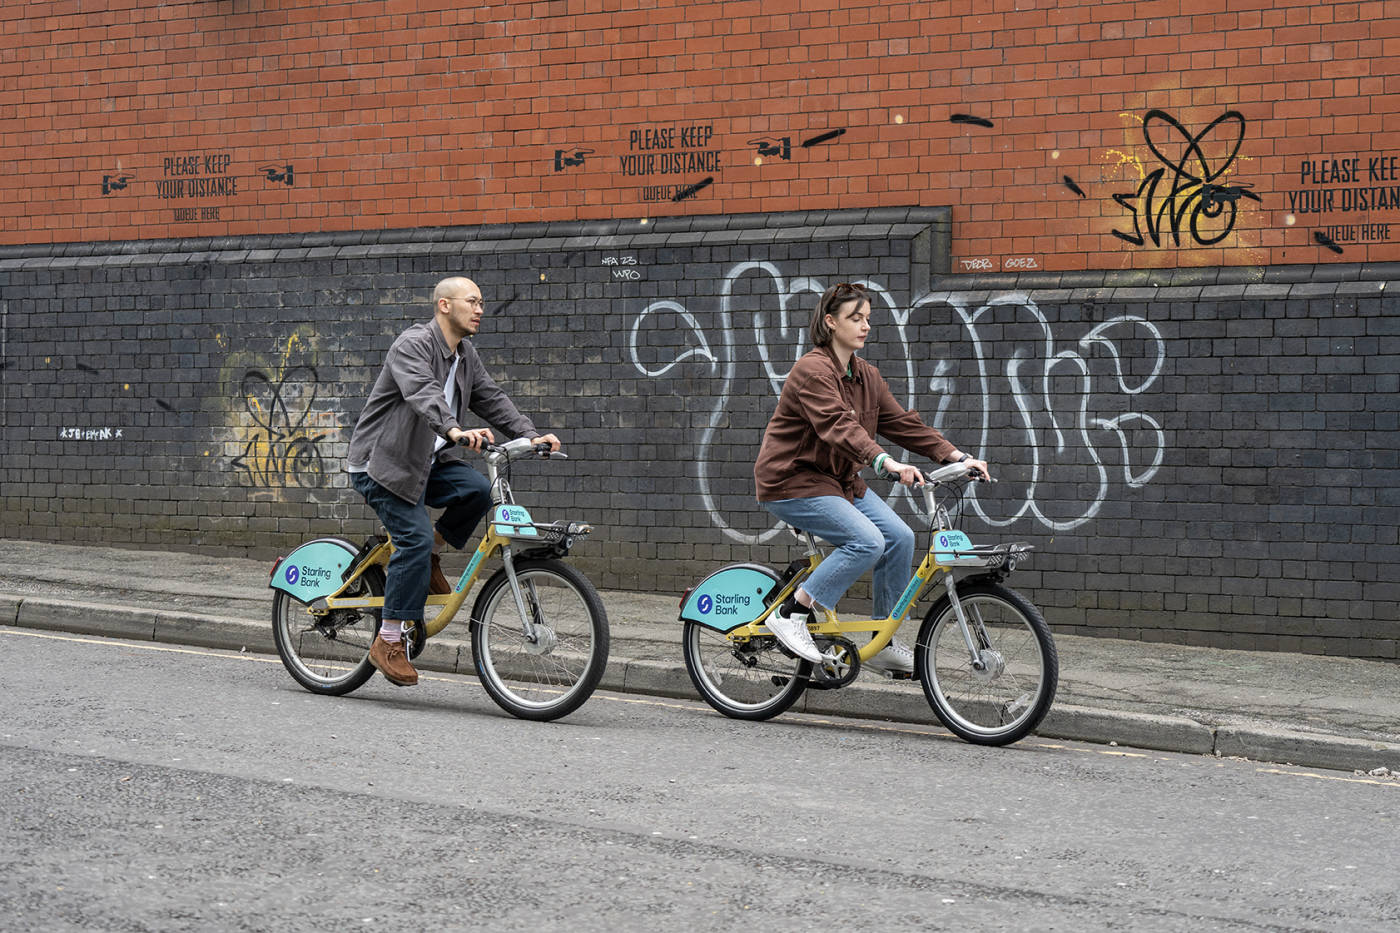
[269,438,609,720]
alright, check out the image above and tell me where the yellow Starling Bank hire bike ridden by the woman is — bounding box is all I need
[680,464,1060,745]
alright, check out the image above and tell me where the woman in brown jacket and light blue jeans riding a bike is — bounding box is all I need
[753,282,991,672]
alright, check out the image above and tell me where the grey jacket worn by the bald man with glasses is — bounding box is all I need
[346,318,539,503]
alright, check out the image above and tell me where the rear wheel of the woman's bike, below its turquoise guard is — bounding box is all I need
[680,622,812,720]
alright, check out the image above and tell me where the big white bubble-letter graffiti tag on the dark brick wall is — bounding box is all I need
[629,261,1166,544]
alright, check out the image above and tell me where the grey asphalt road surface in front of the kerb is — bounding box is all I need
[0,628,1400,933]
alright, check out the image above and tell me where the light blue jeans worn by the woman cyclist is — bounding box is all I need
[763,489,914,619]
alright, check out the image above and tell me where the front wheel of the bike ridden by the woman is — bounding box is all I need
[914,581,1060,745]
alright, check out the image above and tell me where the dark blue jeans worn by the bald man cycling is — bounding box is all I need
[350,461,491,622]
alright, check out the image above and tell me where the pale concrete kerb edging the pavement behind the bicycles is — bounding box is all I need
[0,594,1400,770]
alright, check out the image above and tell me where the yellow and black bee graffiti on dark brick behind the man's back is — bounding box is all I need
[218,332,340,495]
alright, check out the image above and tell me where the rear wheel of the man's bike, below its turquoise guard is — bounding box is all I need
[272,567,384,696]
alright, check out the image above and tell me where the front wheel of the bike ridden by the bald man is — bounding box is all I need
[472,559,609,720]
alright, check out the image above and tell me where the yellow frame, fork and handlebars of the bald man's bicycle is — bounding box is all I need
[309,438,592,637]
